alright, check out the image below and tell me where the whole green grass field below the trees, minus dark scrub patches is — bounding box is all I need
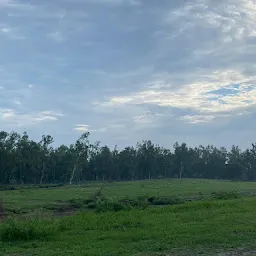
[0,179,256,256]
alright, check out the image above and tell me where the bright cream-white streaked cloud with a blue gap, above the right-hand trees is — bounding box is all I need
[103,70,256,117]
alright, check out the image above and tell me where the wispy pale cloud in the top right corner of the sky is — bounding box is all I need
[164,0,256,41]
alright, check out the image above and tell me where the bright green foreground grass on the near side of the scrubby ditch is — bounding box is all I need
[0,197,256,256]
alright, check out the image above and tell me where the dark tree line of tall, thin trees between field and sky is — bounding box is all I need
[0,131,256,184]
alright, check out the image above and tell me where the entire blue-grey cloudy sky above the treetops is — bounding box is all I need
[0,0,256,148]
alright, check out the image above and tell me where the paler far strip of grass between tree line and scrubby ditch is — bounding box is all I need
[0,179,256,212]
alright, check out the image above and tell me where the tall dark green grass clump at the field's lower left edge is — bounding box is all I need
[0,219,58,242]
